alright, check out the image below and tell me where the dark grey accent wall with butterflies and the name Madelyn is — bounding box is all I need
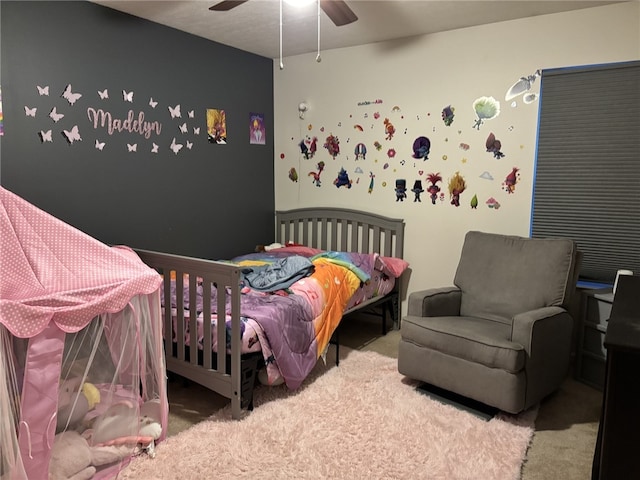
[0,1,275,259]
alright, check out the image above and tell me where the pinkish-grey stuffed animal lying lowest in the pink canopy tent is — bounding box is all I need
[49,430,132,480]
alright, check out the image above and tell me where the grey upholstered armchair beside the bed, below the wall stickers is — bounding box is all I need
[398,231,579,413]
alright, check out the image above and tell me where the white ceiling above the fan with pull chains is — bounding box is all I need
[93,0,637,58]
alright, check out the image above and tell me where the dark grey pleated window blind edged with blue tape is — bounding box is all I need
[531,62,640,282]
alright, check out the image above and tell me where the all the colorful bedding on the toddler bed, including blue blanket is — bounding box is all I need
[162,247,407,389]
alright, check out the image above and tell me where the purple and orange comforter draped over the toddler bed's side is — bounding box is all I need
[162,252,388,389]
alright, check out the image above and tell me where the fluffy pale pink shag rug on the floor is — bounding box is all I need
[118,350,537,480]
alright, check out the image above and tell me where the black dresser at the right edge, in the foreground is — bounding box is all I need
[591,276,640,480]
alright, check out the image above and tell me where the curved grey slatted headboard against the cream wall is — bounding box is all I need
[276,207,404,258]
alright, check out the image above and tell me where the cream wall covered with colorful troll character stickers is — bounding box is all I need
[274,2,640,312]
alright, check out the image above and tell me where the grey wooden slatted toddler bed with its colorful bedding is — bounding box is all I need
[137,208,407,418]
